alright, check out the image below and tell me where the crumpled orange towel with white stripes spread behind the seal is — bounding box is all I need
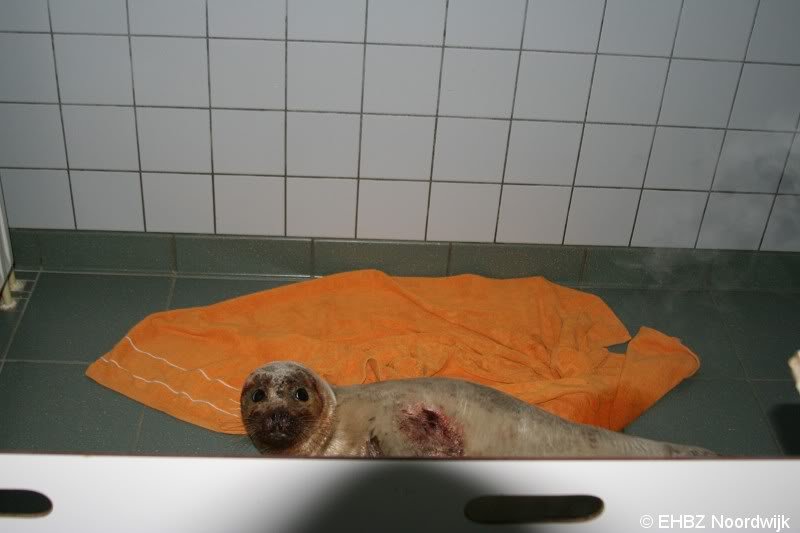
[86,270,699,434]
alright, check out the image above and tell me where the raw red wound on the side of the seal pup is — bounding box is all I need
[397,404,464,457]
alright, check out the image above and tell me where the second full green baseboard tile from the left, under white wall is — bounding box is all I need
[175,235,311,276]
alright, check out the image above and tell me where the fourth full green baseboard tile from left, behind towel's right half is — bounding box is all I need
[449,243,586,284]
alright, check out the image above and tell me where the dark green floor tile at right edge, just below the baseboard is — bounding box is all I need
[713,291,800,379]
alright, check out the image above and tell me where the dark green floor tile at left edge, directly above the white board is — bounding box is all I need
[0,362,142,453]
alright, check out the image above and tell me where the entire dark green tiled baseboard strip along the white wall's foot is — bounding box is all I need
[6,229,800,291]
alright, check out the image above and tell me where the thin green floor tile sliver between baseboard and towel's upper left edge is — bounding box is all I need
[170,278,301,309]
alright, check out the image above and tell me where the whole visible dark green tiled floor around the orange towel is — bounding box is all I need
[0,270,800,456]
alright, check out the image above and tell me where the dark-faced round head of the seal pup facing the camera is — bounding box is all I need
[241,361,336,455]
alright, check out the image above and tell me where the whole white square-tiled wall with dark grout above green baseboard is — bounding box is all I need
[0,0,800,250]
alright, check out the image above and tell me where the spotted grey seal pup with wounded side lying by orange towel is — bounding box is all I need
[241,361,716,457]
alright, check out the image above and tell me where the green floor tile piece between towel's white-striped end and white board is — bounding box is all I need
[135,408,259,457]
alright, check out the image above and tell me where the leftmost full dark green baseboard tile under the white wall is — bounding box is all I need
[36,231,175,273]
